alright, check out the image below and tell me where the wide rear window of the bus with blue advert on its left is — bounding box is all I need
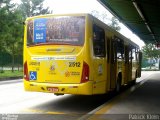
[27,16,85,46]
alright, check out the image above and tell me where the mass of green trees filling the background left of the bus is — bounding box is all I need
[0,0,52,72]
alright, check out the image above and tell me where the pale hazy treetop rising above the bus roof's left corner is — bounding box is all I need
[20,0,51,19]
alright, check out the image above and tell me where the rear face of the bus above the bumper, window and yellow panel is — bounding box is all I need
[26,16,89,84]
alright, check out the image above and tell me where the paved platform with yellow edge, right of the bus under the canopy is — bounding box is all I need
[81,72,160,120]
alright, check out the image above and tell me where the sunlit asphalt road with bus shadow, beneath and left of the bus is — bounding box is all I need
[0,72,156,120]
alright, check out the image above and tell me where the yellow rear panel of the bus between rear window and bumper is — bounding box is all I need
[27,46,83,83]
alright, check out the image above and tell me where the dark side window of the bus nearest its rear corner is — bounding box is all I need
[93,24,106,57]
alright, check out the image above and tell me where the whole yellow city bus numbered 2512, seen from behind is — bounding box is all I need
[24,14,141,95]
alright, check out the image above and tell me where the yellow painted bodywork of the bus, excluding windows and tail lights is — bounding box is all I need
[23,14,141,95]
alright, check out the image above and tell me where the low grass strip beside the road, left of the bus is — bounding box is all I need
[0,70,23,78]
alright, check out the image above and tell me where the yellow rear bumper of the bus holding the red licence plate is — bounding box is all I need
[24,80,93,95]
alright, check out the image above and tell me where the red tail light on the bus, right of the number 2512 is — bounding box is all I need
[81,62,89,83]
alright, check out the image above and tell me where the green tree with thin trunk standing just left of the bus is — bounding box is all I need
[5,9,23,72]
